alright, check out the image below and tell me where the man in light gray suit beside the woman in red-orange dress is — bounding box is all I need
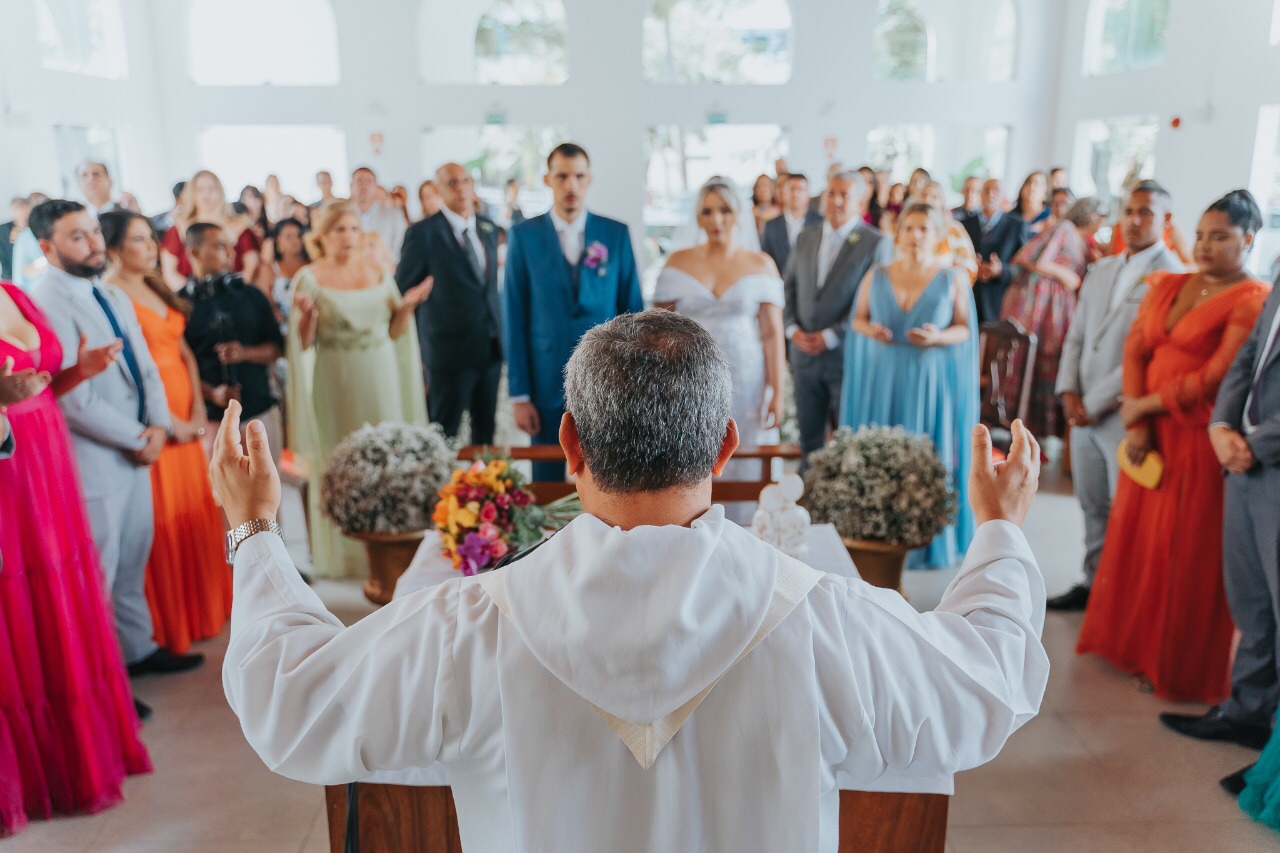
[1048,181,1183,610]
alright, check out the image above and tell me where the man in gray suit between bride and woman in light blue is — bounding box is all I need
[782,172,893,456]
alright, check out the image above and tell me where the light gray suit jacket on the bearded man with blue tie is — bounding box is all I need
[31,268,172,498]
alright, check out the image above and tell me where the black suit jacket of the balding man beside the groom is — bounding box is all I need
[396,213,502,370]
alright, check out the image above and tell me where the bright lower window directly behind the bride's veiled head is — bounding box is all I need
[644,124,787,284]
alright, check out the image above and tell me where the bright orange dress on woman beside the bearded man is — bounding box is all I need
[134,305,232,652]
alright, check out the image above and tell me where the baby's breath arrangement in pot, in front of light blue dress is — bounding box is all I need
[804,427,956,547]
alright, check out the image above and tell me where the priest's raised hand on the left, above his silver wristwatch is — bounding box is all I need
[209,401,280,528]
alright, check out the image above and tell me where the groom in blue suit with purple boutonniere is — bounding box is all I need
[503,142,644,482]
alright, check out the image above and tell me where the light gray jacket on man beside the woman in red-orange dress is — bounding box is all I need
[1056,245,1183,420]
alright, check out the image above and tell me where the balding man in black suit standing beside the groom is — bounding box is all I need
[396,163,502,444]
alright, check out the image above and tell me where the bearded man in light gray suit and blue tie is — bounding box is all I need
[31,200,204,675]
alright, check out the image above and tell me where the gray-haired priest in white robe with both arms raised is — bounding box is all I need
[211,311,1048,853]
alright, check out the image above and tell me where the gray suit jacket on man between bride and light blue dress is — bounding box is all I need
[782,222,893,364]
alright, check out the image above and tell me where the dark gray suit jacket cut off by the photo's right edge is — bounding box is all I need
[1210,286,1280,467]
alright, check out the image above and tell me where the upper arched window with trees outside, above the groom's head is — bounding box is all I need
[475,0,568,86]
